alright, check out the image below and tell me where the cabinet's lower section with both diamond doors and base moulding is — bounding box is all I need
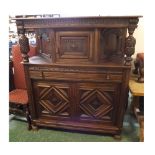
[31,81,121,134]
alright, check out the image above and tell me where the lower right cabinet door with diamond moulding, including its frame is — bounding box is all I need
[79,83,120,123]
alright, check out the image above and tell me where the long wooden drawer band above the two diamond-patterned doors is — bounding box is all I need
[29,68,123,82]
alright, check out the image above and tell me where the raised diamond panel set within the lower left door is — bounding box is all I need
[39,86,69,115]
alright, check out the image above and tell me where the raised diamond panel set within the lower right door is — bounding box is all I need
[80,89,113,119]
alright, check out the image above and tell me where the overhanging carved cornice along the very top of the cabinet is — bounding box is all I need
[12,15,141,29]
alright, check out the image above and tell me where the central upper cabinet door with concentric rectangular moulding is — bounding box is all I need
[56,31,93,62]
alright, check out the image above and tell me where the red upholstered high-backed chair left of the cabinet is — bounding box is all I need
[9,45,36,130]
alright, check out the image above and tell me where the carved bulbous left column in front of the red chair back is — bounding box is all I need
[19,30,30,62]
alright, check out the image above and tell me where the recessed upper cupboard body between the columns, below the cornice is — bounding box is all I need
[36,28,127,63]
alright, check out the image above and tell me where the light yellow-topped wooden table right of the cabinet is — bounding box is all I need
[129,76,144,141]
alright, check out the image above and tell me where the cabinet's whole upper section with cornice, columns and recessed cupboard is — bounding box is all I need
[15,16,139,65]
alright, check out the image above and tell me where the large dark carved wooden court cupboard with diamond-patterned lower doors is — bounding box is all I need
[15,16,139,135]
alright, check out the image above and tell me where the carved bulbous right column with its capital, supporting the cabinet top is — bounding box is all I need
[125,18,139,66]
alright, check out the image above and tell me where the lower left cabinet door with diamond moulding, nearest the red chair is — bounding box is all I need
[33,81,70,119]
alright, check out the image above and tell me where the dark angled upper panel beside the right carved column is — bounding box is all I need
[100,28,127,61]
